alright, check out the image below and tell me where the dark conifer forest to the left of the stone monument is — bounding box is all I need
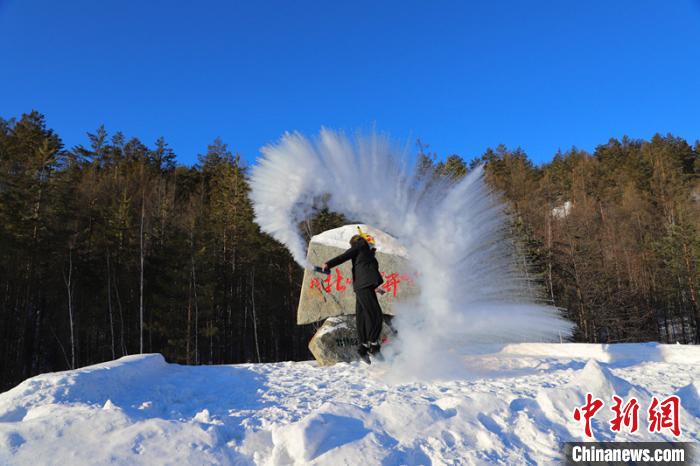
[0,112,342,390]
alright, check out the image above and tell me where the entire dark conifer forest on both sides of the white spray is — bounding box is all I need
[0,112,700,390]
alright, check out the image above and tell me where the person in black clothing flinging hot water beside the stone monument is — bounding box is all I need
[321,227,384,364]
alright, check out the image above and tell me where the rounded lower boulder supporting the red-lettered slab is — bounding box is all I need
[309,315,394,366]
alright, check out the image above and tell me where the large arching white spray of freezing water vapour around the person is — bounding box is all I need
[251,129,571,377]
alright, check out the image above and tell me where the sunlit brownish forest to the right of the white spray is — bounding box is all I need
[421,135,700,343]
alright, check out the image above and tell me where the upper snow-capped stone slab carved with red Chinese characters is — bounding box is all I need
[297,224,418,325]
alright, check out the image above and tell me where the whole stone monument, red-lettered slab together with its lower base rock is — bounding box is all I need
[297,224,418,365]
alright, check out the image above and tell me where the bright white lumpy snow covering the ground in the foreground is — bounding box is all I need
[0,344,700,465]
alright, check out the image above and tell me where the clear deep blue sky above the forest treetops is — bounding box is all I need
[0,0,700,164]
